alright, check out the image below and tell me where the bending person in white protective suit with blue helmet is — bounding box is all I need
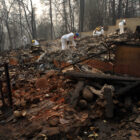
[61,33,79,50]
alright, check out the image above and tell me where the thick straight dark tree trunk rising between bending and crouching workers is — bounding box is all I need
[79,0,85,32]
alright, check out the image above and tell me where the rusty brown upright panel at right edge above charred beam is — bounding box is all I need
[114,45,140,77]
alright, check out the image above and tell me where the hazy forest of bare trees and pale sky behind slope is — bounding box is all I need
[0,0,140,51]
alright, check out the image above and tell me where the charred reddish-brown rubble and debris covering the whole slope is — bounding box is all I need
[0,34,140,140]
